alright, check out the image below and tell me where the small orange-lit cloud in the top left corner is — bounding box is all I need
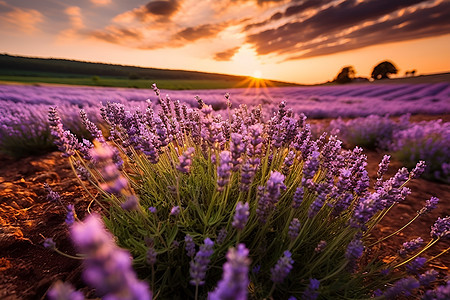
[0,1,44,34]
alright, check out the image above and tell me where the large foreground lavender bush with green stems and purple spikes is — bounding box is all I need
[43,86,450,299]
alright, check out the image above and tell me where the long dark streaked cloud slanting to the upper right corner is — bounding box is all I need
[247,0,442,59]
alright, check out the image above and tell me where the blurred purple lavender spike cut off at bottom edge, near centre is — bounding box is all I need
[208,244,250,300]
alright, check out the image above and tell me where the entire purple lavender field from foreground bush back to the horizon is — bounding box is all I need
[0,83,450,299]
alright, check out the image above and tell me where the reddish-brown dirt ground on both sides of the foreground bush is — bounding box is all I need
[0,137,450,300]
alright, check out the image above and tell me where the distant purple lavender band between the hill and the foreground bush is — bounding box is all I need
[0,82,450,118]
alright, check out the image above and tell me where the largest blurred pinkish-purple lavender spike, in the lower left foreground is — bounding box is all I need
[70,214,152,300]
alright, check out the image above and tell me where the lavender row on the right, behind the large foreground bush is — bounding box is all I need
[326,115,450,182]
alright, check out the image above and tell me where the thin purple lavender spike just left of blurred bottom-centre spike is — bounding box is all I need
[189,238,214,286]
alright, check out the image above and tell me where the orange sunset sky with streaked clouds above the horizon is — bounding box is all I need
[0,0,450,84]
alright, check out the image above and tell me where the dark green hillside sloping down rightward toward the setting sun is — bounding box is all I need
[0,54,297,90]
